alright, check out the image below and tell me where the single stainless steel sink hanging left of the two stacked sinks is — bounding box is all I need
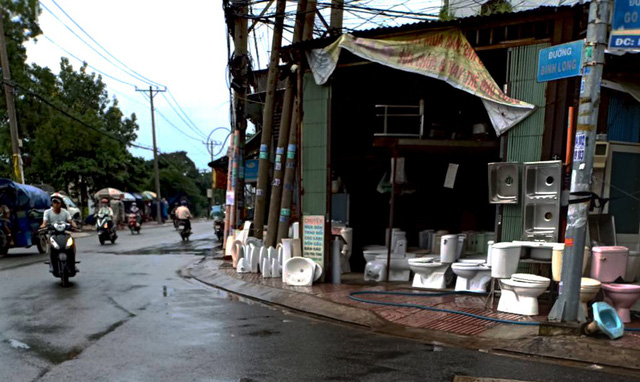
[488,162,520,204]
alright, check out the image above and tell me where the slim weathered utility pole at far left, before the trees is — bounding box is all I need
[0,8,24,183]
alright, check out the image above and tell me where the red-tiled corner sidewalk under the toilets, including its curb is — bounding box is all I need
[185,257,640,377]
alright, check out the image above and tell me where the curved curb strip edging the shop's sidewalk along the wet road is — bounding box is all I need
[186,259,640,375]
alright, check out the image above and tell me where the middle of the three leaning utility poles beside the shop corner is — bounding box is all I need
[265,0,307,247]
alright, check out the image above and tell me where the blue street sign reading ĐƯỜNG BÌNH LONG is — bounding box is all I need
[538,40,584,82]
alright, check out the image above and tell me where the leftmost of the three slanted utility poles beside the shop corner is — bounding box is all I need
[253,0,287,239]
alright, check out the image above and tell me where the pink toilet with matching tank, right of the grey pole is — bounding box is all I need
[591,247,640,323]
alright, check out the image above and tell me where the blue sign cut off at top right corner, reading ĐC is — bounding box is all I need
[609,0,640,49]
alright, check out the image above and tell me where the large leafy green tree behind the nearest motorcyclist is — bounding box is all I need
[19,58,140,200]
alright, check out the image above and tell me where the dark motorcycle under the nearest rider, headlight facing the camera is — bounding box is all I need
[41,222,80,287]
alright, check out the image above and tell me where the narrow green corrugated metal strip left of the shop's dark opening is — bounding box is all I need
[302,74,331,216]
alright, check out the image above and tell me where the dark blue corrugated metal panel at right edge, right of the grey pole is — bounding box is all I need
[607,92,640,143]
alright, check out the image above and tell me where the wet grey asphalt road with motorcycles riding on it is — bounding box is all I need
[0,222,637,381]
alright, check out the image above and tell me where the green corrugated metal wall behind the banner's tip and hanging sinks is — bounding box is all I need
[501,44,549,241]
